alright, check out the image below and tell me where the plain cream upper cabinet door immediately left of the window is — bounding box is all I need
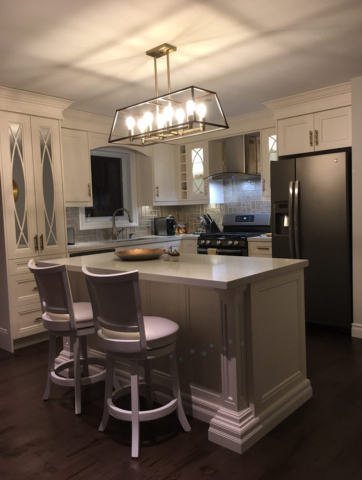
[62,128,93,207]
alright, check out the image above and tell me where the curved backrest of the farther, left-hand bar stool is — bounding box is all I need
[28,260,77,330]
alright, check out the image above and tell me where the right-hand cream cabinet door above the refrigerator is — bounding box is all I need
[314,107,352,151]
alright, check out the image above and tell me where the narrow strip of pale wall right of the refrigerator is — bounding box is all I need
[351,77,362,338]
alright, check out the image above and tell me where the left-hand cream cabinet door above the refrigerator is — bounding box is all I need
[278,114,314,156]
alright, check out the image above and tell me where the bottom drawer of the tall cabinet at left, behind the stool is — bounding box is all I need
[10,305,46,339]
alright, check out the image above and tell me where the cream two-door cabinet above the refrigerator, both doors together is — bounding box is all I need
[278,107,352,156]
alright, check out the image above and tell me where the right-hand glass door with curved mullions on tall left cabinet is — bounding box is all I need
[31,117,66,255]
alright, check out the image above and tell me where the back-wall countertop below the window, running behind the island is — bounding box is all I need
[68,233,199,253]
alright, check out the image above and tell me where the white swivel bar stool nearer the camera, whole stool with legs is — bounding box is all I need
[83,267,191,458]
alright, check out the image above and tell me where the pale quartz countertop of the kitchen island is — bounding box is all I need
[43,253,308,290]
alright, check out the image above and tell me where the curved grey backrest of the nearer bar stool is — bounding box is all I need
[83,267,147,352]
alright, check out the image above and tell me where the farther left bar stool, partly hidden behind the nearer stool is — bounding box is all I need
[28,260,106,415]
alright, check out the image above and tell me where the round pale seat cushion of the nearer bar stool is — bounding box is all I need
[99,316,179,350]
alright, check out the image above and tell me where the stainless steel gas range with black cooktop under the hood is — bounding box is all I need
[197,213,270,257]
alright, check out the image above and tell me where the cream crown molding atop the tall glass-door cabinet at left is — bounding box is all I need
[0,87,73,120]
